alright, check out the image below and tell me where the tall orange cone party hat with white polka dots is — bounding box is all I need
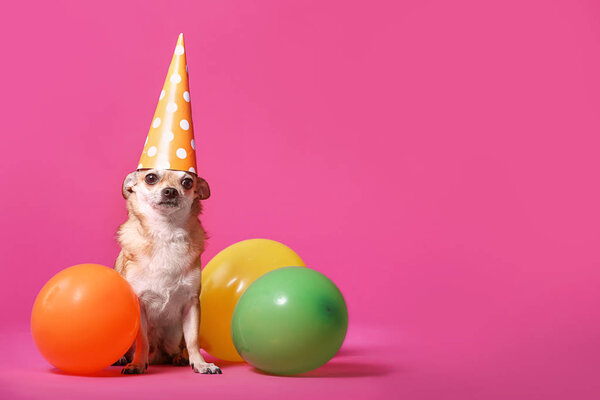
[138,33,197,173]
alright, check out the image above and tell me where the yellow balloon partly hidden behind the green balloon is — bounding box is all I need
[199,239,306,361]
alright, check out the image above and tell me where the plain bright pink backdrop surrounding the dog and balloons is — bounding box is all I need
[0,0,600,399]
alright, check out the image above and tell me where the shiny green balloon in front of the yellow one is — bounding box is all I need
[231,267,348,375]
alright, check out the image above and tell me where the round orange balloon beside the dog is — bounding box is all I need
[31,264,140,374]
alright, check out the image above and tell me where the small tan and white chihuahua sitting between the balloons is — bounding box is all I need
[115,169,221,374]
